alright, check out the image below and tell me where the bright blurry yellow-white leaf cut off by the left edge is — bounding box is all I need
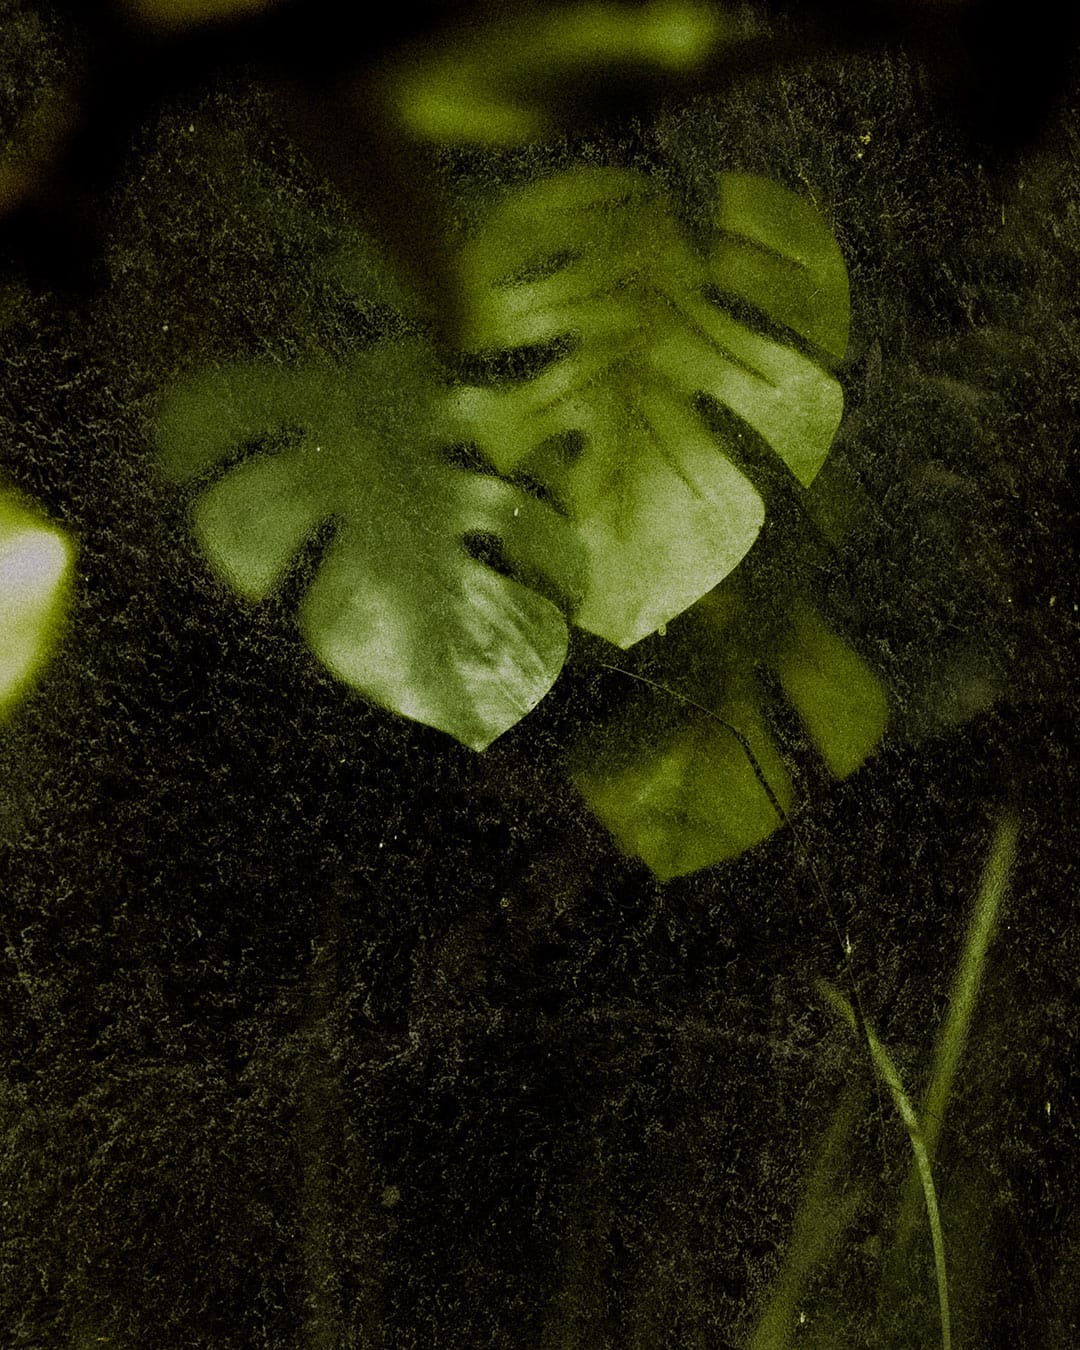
[0,491,74,716]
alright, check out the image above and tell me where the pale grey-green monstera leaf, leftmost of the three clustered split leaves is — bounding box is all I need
[158,342,579,749]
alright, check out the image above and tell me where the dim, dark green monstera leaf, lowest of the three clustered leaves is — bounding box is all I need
[570,574,888,880]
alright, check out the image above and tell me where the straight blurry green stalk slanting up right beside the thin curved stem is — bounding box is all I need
[894,815,1018,1261]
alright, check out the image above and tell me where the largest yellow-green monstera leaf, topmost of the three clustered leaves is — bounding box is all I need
[458,169,849,647]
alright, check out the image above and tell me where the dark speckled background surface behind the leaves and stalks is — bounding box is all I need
[0,3,1080,1350]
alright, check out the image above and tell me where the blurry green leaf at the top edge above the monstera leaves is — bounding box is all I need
[383,0,744,146]
